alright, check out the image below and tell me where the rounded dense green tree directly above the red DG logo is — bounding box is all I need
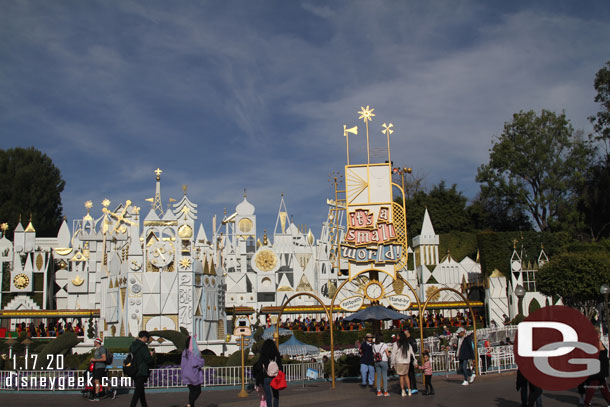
[536,250,610,318]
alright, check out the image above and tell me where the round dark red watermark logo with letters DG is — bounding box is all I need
[514,305,600,390]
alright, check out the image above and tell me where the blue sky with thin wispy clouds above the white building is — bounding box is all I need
[0,0,610,234]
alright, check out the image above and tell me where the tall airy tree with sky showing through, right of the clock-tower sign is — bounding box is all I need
[476,110,592,231]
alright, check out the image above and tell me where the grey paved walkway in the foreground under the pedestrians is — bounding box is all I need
[0,372,607,407]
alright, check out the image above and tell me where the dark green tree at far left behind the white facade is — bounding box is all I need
[0,147,65,237]
